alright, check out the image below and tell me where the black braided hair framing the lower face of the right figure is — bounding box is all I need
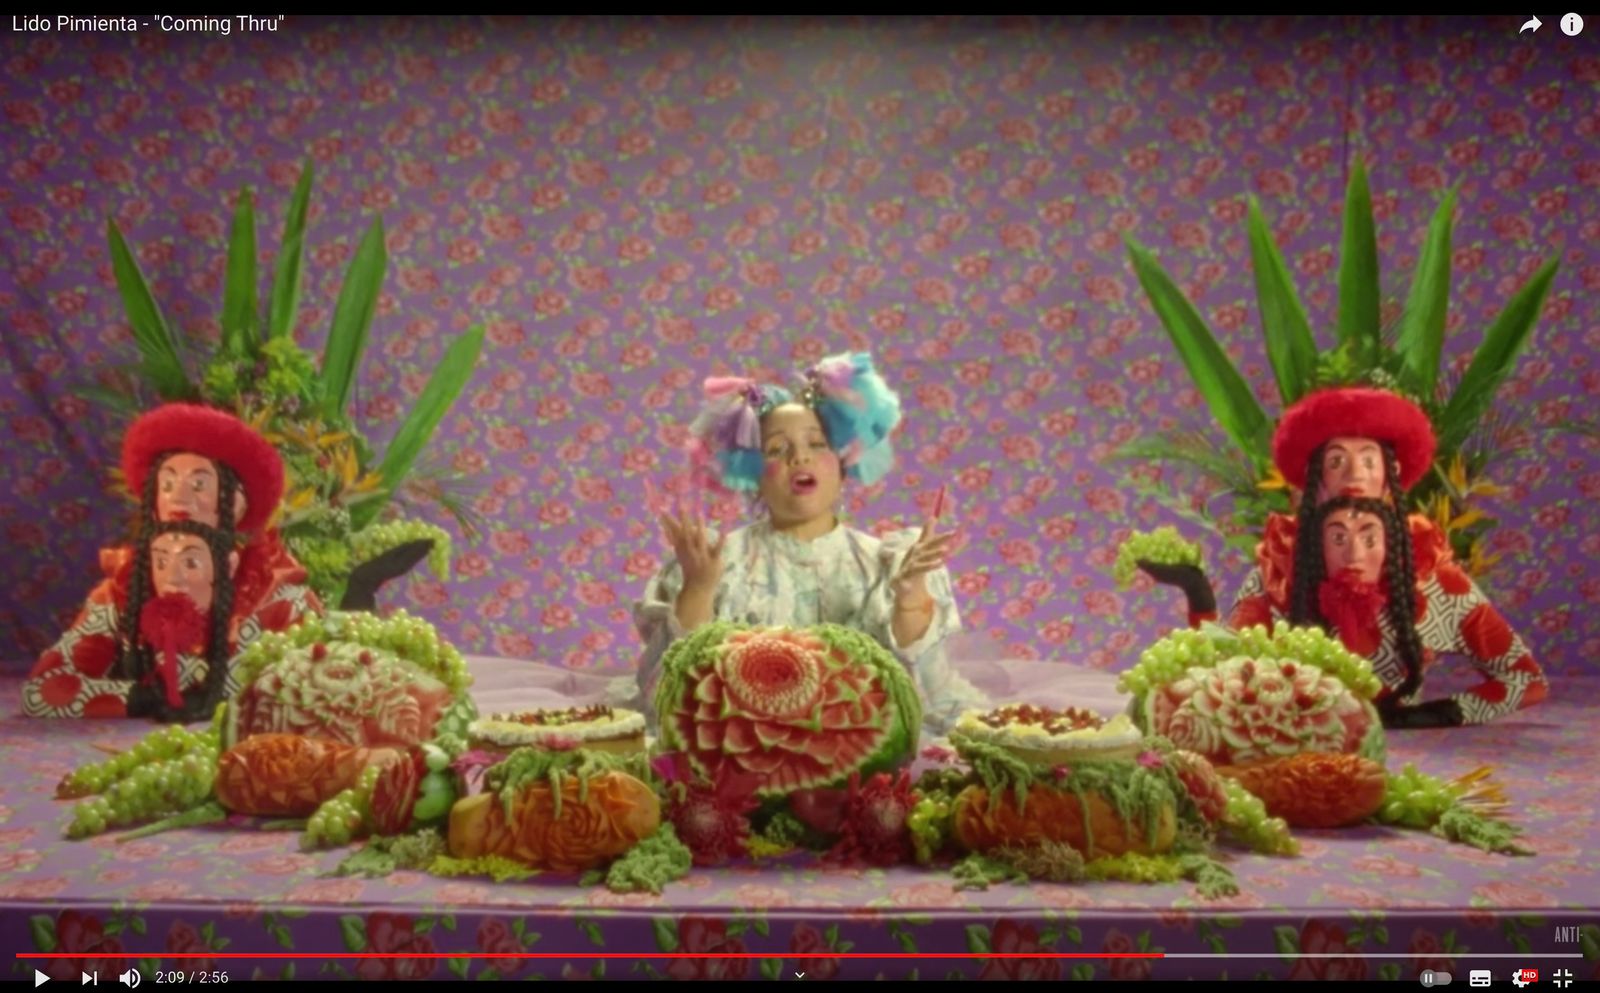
[1290,496,1422,700]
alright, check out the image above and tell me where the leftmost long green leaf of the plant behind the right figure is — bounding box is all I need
[1128,235,1270,467]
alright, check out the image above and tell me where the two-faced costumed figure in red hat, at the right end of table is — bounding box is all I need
[1139,387,1549,728]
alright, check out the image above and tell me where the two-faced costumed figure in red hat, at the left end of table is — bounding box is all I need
[22,403,322,721]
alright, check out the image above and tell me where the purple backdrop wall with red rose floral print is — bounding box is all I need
[0,18,1600,673]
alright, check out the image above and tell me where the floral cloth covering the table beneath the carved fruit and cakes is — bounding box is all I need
[0,659,1600,983]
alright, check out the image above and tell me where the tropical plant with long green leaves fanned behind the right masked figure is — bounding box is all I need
[1118,154,1560,574]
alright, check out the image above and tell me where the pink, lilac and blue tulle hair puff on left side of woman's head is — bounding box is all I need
[688,376,790,493]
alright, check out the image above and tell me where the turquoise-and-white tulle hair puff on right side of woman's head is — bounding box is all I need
[800,352,901,486]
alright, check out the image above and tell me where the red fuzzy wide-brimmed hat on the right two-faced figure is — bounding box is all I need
[1272,387,1437,489]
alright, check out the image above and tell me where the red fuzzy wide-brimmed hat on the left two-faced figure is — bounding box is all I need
[122,403,283,532]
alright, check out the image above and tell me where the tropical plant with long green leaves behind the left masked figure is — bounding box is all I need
[83,162,483,606]
